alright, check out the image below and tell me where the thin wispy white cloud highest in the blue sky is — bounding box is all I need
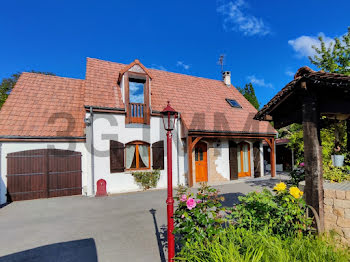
[217,0,270,36]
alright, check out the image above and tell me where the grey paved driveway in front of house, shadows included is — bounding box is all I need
[0,176,286,262]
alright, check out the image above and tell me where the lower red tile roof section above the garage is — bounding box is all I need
[0,73,85,137]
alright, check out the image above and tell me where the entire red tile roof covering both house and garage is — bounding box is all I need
[0,58,276,137]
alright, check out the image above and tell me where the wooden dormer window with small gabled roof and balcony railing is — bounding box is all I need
[118,60,152,125]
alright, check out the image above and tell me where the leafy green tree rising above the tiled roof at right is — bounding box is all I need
[309,27,350,75]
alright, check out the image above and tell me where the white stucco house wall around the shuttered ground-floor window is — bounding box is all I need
[86,113,185,194]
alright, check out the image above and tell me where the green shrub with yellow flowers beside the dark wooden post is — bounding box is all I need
[230,182,312,236]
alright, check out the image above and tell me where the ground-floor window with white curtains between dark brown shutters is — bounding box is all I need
[125,142,151,169]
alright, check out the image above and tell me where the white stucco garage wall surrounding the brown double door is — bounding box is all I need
[0,142,91,204]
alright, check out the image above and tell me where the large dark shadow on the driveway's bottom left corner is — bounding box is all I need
[0,238,98,262]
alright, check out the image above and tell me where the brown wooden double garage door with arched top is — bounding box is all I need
[7,149,81,202]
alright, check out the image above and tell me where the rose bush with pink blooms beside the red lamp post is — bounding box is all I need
[174,184,224,243]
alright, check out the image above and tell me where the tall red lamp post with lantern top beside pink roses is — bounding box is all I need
[161,101,178,262]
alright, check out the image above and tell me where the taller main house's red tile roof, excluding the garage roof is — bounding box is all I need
[85,58,276,133]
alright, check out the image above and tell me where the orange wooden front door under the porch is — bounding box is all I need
[194,142,208,182]
